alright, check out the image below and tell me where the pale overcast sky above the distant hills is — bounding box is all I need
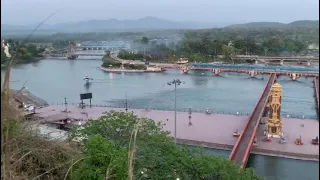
[1,0,319,25]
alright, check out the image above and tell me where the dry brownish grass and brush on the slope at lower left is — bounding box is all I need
[1,93,81,180]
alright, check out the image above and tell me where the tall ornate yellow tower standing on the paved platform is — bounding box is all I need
[266,83,283,138]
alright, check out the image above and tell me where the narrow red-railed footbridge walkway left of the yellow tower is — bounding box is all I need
[229,74,276,168]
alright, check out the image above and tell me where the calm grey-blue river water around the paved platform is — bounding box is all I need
[1,59,319,180]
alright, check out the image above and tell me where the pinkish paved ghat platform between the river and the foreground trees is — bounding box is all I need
[36,106,319,161]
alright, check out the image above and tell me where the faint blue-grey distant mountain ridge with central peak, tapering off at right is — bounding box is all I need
[1,17,229,32]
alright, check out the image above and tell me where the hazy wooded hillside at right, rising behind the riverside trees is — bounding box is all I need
[185,20,319,44]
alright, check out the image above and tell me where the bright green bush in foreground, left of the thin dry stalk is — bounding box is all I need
[70,135,128,180]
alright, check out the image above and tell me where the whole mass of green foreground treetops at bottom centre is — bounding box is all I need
[72,112,258,180]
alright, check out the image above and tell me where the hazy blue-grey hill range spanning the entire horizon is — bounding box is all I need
[1,16,319,37]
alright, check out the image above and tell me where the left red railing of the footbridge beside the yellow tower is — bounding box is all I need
[229,75,273,160]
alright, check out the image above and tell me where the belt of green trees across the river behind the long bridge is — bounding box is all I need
[127,34,307,63]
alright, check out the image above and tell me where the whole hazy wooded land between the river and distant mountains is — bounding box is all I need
[5,21,319,62]
